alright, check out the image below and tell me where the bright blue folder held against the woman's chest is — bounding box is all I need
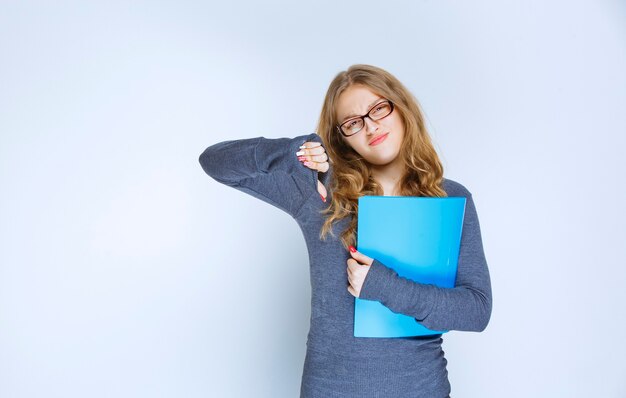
[354,195,466,337]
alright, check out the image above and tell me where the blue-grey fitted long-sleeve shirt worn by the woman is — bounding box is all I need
[200,133,492,397]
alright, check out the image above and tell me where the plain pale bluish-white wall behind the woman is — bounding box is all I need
[0,0,626,398]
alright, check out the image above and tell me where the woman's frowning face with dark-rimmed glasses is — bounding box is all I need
[335,84,404,166]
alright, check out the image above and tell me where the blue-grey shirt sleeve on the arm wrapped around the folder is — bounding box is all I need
[359,194,492,332]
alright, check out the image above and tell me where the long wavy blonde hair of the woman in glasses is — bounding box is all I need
[317,64,447,249]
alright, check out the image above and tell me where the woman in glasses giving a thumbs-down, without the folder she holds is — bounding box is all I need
[200,65,492,398]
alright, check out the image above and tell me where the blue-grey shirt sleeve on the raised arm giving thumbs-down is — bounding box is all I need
[199,133,320,218]
